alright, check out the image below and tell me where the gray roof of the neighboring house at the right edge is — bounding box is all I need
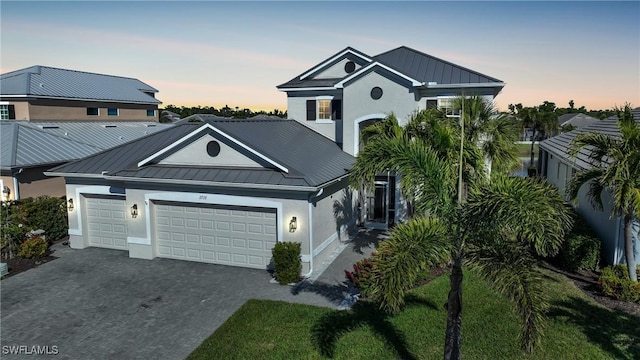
[540,107,640,170]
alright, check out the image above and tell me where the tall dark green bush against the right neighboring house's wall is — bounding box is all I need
[556,213,601,271]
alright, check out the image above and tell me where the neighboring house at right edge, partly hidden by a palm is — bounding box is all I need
[538,108,640,264]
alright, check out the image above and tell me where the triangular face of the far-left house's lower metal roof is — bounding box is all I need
[25,120,173,150]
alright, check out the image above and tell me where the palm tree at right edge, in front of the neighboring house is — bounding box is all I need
[567,104,640,282]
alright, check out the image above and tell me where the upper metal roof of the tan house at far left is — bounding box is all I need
[0,65,161,105]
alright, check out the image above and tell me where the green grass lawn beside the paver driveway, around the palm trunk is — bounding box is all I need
[188,273,640,360]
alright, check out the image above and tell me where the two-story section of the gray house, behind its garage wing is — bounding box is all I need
[278,46,505,228]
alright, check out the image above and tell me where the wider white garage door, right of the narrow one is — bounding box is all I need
[153,203,277,269]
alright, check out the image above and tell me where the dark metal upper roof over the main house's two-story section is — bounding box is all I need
[278,46,504,90]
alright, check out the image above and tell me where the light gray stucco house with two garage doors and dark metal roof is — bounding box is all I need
[47,47,505,275]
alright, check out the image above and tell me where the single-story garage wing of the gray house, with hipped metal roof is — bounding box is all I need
[46,115,355,274]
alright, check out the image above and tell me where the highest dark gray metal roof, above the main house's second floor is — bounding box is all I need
[277,46,503,89]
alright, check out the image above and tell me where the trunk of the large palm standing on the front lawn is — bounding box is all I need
[444,256,462,360]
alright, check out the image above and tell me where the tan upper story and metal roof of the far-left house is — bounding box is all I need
[0,65,161,122]
